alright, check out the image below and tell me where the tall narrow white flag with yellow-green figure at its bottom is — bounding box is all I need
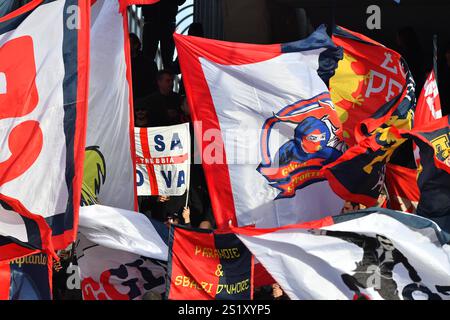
[83,0,136,210]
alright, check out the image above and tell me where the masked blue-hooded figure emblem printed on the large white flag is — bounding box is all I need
[257,92,344,199]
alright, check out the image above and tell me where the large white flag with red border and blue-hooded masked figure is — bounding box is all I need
[174,27,343,227]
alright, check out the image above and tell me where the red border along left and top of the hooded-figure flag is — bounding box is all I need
[174,34,281,228]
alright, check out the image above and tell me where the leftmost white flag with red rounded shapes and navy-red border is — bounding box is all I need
[0,0,89,255]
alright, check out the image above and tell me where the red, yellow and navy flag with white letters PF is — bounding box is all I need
[323,27,415,207]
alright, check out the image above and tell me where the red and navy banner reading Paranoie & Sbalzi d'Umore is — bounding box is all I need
[166,226,253,300]
